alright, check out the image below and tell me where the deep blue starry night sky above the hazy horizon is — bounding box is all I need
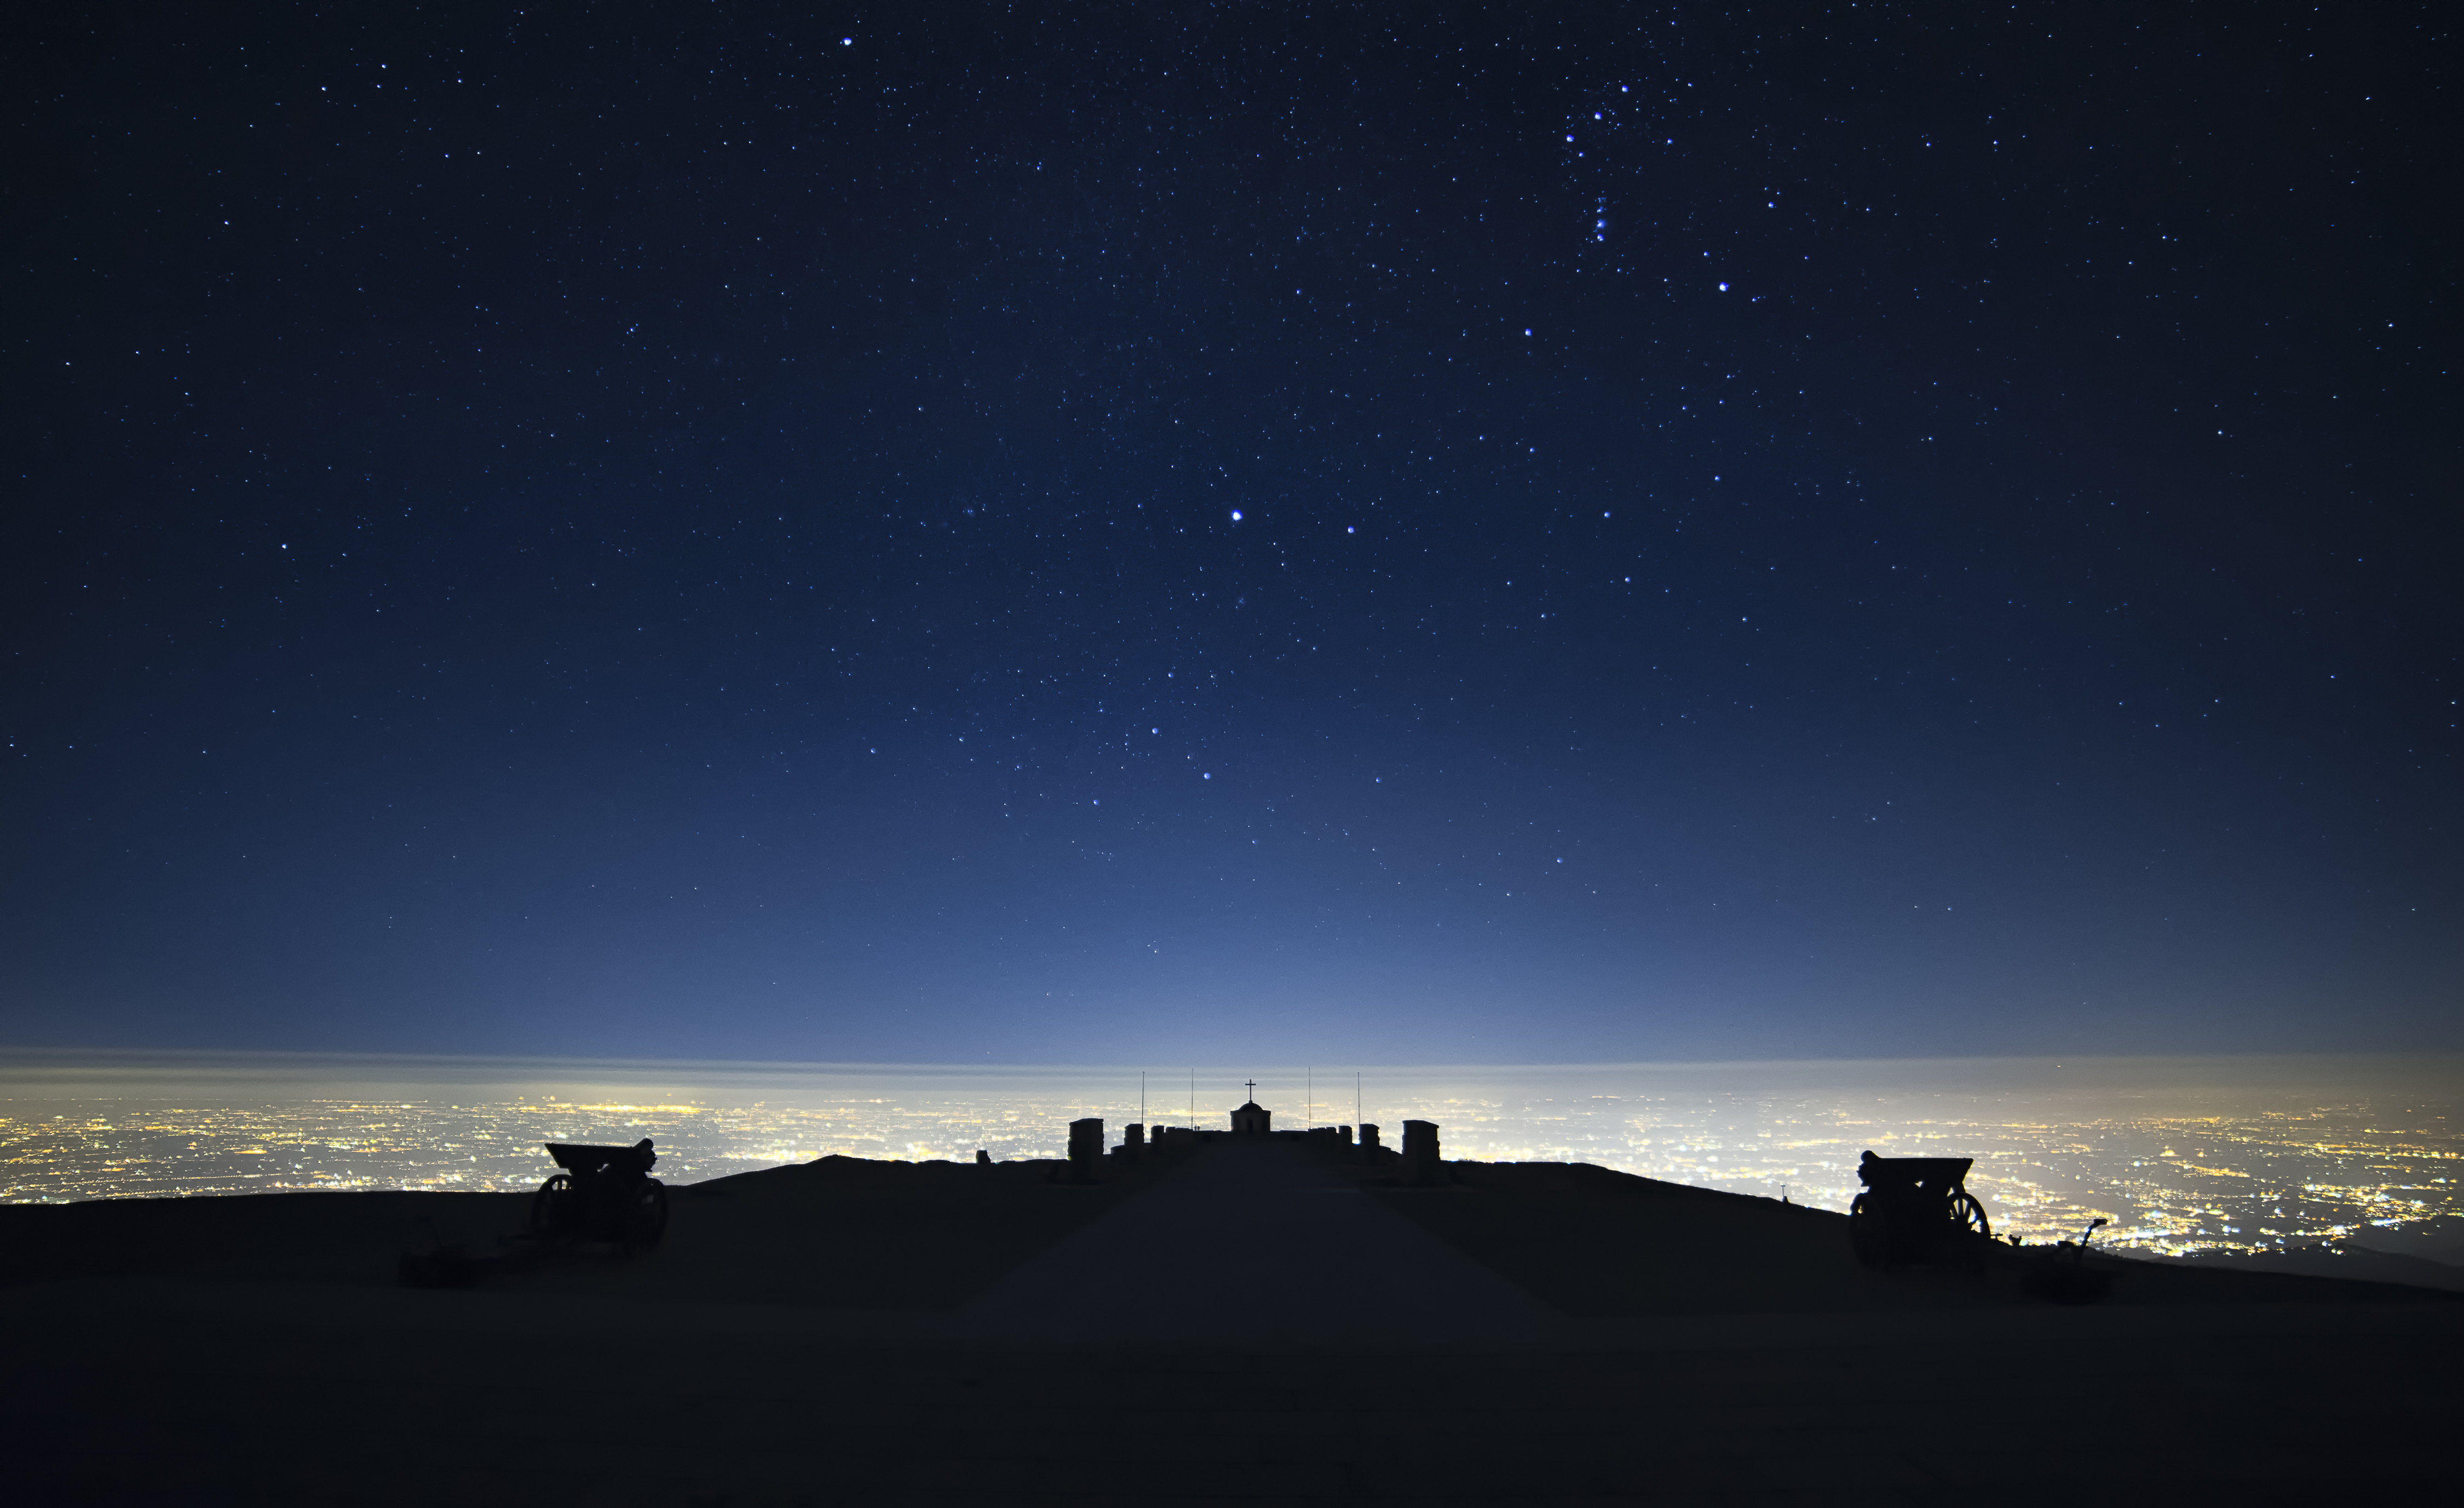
[0,3,2464,1064]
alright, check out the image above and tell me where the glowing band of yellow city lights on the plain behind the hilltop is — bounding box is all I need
[0,1069,2464,1254]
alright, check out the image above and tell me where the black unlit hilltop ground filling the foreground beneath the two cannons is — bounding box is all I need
[0,1143,2464,1508]
